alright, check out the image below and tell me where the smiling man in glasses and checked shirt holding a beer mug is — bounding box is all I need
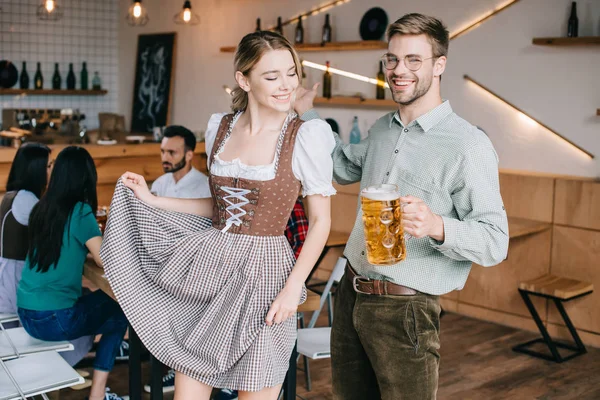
[296,14,508,400]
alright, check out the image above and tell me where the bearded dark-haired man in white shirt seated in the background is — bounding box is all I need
[150,125,210,199]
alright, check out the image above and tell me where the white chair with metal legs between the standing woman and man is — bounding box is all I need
[298,257,347,391]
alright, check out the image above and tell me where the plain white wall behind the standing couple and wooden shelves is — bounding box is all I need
[119,0,600,176]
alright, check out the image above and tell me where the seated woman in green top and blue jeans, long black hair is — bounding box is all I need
[17,146,127,400]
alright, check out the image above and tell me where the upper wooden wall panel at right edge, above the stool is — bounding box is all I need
[554,179,600,229]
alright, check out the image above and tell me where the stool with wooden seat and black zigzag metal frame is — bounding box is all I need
[513,275,594,363]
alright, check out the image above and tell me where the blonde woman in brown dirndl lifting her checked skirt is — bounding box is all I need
[101,31,335,400]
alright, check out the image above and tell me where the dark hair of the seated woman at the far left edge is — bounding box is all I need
[6,143,50,199]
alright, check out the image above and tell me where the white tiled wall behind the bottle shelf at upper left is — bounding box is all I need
[0,0,119,128]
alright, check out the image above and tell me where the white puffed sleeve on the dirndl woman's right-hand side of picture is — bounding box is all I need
[292,119,336,196]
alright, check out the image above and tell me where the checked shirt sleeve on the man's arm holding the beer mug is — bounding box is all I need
[429,145,509,267]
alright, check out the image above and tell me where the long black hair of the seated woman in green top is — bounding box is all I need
[27,146,98,272]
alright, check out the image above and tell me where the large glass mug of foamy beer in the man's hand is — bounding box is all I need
[360,184,406,265]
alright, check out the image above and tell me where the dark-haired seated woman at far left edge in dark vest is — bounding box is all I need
[0,143,52,314]
